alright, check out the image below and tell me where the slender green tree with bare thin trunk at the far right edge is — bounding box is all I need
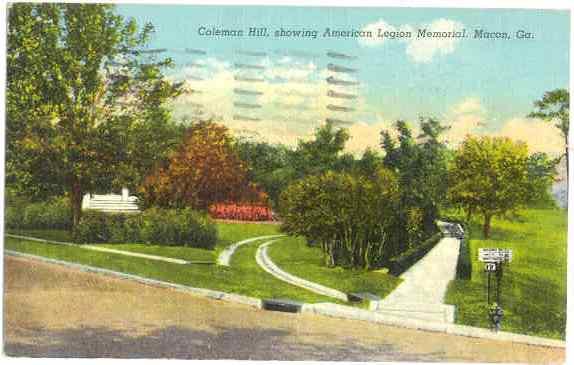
[528,89,570,182]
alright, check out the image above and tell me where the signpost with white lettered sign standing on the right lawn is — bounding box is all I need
[478,248,512,331]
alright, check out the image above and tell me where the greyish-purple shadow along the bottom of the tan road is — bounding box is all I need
[5,326,452,361]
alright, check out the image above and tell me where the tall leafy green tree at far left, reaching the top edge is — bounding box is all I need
[6,3,182,224]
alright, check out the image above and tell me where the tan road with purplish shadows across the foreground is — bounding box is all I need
[4,257,564,363]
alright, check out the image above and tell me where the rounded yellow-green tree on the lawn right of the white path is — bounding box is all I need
[449,136,533,238]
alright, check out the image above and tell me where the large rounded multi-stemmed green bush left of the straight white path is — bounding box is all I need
[280,169,398,269]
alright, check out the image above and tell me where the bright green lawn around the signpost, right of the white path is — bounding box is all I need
[446,209,567,339]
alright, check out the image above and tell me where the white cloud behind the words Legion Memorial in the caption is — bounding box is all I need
[359,18,464,63]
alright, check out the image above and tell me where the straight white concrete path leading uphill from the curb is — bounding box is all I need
[371,223,460,323]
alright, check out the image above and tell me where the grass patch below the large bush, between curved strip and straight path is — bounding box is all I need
[268,237,401,298]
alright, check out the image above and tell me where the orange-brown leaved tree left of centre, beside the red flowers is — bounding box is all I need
[140,121,265,210]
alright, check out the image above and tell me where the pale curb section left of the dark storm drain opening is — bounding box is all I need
[4,250,263,309]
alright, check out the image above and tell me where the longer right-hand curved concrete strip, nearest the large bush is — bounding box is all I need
[255,239,348,302]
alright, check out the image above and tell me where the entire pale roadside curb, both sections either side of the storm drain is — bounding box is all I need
[4,250,566,348]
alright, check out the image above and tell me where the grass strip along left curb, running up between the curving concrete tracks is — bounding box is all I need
[5,224,334,303]
